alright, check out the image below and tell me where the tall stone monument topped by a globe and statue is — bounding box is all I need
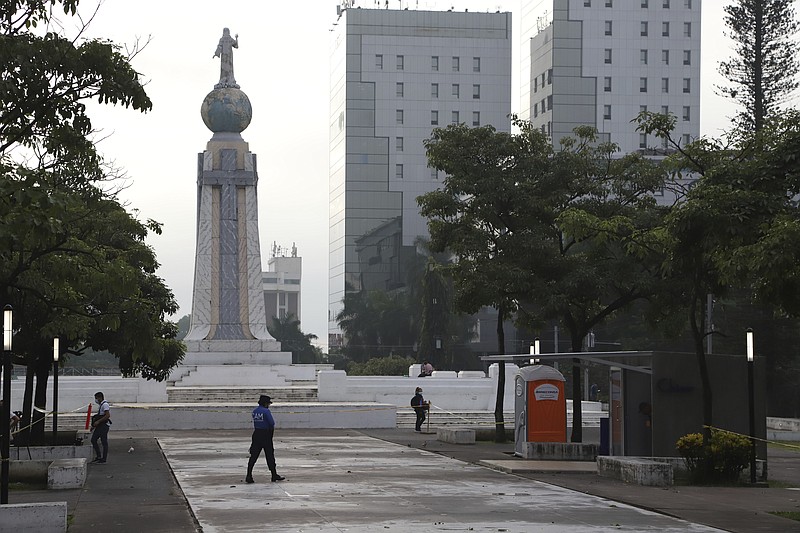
[184,28,291,364]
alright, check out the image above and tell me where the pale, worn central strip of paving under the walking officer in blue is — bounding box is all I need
[158,431,718,533]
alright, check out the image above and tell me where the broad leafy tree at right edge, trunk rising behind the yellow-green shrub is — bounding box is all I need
[638,111,800,443]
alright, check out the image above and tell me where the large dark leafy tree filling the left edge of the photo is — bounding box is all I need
[0,0,185,440]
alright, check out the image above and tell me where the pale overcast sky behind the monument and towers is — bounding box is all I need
[73,0,752,350]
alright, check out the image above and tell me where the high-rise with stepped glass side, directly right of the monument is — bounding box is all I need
[328,6,512,346]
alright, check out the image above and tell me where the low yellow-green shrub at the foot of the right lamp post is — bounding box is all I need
[676,429,750,484]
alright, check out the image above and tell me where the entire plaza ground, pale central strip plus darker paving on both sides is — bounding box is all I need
[12,428,800,533]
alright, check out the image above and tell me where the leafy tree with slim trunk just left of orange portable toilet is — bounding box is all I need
[417,124,548,442]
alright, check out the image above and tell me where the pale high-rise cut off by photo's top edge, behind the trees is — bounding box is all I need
[520,0,701,153]
